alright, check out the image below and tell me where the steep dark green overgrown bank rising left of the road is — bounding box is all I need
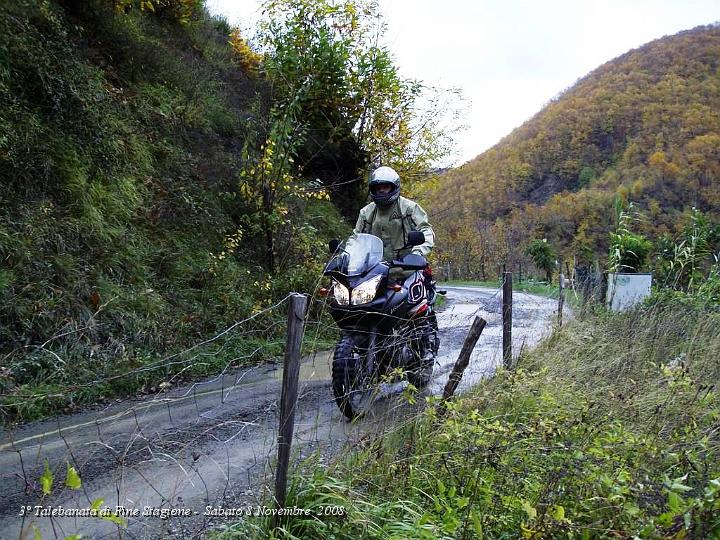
[0,0,345,422]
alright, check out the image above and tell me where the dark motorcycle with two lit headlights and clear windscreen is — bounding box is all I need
[324,231,445,420]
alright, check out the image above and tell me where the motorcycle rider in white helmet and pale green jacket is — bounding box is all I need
[355,167,435,367]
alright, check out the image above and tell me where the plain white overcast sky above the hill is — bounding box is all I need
[206,0,720,164]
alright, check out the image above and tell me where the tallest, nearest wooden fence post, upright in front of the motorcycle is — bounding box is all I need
[275,293,307,525]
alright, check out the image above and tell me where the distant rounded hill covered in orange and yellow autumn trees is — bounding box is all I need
[424,25,720,276]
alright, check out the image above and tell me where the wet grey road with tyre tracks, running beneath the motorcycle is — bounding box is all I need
[0,287,557,539]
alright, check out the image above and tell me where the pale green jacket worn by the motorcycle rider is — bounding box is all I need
[355,197,435,261]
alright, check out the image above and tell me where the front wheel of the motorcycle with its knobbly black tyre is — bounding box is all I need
[332,334,379,420]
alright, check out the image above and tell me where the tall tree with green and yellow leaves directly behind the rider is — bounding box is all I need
[234,0,462,272]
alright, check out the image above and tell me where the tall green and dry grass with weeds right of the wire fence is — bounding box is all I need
[221,300,720,538]
